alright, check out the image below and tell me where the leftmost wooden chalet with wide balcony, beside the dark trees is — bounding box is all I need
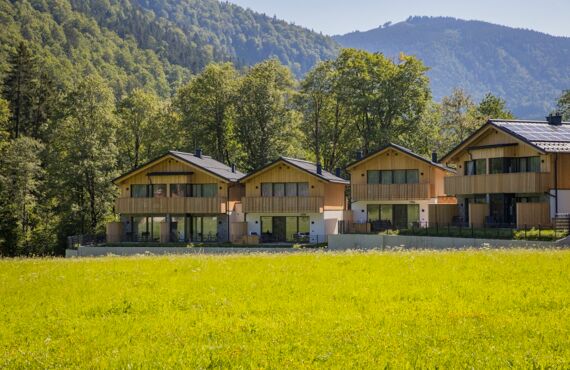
[107,149,244,243]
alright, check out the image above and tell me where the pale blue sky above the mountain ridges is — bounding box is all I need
[224,0,570,37]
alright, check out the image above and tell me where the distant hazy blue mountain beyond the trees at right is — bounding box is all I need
[333,17,570,118]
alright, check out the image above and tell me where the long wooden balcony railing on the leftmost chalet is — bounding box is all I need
[115,197,226,215]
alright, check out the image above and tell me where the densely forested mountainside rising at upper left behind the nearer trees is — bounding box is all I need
[0,0,339,96]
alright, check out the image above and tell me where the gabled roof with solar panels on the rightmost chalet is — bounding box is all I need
[442,119,570,161]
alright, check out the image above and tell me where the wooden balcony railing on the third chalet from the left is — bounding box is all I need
[351,183,430,202]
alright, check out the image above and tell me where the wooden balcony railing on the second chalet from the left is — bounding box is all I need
[242,197,324,213]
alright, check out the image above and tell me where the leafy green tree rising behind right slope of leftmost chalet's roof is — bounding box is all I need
[175,63,239,163]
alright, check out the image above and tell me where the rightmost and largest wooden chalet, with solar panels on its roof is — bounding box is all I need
[442,116,570,227]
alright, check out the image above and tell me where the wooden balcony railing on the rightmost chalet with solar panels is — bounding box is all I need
[445,172,551,195]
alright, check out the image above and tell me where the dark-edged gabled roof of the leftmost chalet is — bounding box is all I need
[113,150,245,182]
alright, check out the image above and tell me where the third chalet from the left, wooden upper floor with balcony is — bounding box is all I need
[346,144,455,231]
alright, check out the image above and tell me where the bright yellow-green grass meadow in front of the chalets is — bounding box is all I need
[0,250,570,369]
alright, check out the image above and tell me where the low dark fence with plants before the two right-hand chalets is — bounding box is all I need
[339,222,568,241]
